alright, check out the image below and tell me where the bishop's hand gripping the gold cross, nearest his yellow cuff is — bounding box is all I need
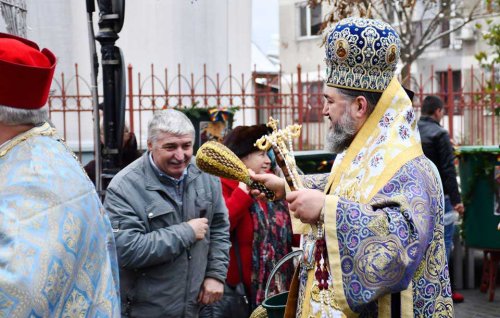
[286,189,326,224]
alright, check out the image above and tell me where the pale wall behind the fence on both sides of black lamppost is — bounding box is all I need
[5,0,252,148]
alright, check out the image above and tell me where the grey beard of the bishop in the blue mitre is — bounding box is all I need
[326,109,356,153]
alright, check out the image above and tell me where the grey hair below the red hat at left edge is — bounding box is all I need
[0,105,49,126]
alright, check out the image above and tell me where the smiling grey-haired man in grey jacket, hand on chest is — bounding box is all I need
[104,109,230,318]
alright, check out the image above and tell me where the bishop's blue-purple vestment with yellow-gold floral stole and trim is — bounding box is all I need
[294,78,453,318]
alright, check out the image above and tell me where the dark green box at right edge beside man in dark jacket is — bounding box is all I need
[458,146,500,249]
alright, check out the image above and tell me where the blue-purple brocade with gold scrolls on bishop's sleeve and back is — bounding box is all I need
[337,157,453,317]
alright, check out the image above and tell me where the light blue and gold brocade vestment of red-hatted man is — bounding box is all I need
[0,124,120,317]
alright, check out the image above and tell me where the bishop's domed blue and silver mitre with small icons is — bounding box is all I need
[325,17,401,92]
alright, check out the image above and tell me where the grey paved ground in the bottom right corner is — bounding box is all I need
[454,286,500,318]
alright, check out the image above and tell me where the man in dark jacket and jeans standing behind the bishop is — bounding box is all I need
[418,96,464,303]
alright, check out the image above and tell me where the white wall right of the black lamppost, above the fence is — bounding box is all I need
[118,0,251,74]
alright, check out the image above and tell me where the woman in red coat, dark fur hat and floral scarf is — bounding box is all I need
[221,125,293,308]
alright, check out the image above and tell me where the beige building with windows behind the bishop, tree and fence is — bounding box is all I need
[279,0,500,143]
